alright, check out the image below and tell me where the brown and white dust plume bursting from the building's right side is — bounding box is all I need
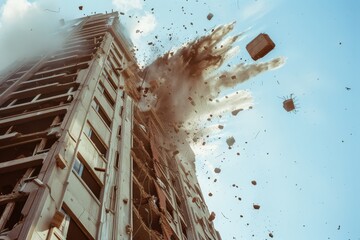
[139,23,284,130]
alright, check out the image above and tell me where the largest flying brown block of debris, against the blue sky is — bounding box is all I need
[246,33,275,61]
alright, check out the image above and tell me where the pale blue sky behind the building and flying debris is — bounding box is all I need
[0,0,360,240]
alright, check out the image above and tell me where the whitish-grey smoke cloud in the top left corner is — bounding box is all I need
[0,0,62,70]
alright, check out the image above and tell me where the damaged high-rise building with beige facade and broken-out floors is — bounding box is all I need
[0,13,221,240]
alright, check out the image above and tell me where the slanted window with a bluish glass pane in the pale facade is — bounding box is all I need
[73,155,101,199]
